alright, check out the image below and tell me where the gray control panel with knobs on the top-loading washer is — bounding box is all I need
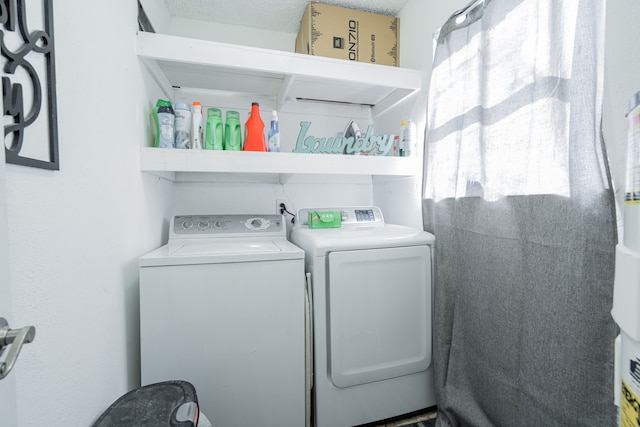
[170,215,286,238]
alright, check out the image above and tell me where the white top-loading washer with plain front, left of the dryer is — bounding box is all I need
[139,215,307,427]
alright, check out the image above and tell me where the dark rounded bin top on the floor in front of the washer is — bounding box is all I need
[93,381,200,427]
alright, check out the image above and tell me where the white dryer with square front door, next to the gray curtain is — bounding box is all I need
[290,207,435,427]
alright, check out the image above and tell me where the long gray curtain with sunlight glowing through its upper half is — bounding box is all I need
[423,0,617,427]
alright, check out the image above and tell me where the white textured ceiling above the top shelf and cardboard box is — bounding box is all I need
[164,0,407,33]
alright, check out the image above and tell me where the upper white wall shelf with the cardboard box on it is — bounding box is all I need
[137,32,421,117]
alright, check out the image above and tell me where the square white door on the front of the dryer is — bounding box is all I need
[327,246,431,388]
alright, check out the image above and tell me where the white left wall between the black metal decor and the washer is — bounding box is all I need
[6,0,172,427]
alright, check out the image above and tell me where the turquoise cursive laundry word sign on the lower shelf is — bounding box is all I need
[293,122,394,156]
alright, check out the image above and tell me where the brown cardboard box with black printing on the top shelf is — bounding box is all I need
[296,2,400,67]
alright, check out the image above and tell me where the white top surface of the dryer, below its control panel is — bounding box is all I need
[291,224,435,256]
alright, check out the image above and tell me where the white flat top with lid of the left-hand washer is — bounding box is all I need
[139,238,304,267]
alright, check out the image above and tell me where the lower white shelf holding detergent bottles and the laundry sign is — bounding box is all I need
[140,147,417,179]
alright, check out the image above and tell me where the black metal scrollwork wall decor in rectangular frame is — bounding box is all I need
[0,0,60,170]
